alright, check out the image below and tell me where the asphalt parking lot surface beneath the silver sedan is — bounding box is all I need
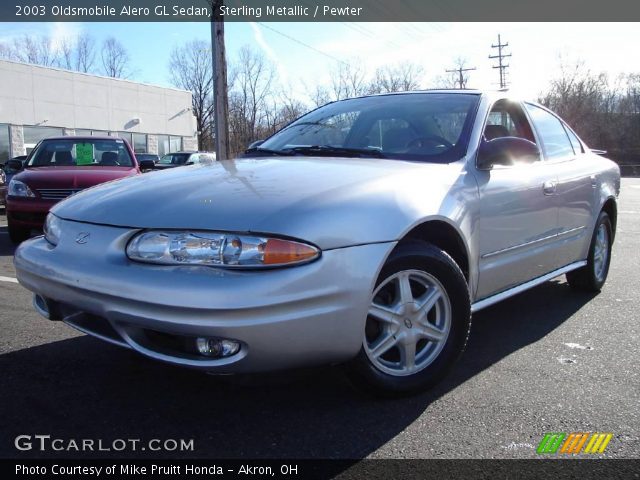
[0,178,640,458]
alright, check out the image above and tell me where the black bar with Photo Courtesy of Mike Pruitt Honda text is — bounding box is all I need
[0,459,640,480]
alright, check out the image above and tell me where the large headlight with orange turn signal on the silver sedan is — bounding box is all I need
[127,231,320,268]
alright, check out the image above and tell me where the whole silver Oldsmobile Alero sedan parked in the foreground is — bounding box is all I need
[15,91,620,393]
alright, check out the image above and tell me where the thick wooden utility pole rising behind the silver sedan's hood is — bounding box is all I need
[210,0,229,160]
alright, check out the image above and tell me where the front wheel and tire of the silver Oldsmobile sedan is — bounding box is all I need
[347,241,471,396]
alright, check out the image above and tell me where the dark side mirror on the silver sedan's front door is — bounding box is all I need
[476,137,540,170]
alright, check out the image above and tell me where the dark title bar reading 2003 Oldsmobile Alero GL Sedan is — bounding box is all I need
[0,0,640,22]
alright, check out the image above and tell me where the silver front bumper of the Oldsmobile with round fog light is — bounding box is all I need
[15,221,395,373]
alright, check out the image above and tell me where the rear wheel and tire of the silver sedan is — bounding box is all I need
[566,212,613,292]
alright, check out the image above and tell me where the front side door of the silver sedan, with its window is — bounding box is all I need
[476,99,558,299]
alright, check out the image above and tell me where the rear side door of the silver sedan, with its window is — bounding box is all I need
[526,103,598,268]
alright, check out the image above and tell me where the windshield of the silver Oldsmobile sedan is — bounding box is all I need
[251,93,480,162]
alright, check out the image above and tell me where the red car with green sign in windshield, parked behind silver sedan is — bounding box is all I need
[6,137,153,243]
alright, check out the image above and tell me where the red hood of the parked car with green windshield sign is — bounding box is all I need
[13,167,137,189]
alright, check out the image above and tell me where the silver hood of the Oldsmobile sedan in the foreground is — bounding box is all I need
[52,157,463,249]
